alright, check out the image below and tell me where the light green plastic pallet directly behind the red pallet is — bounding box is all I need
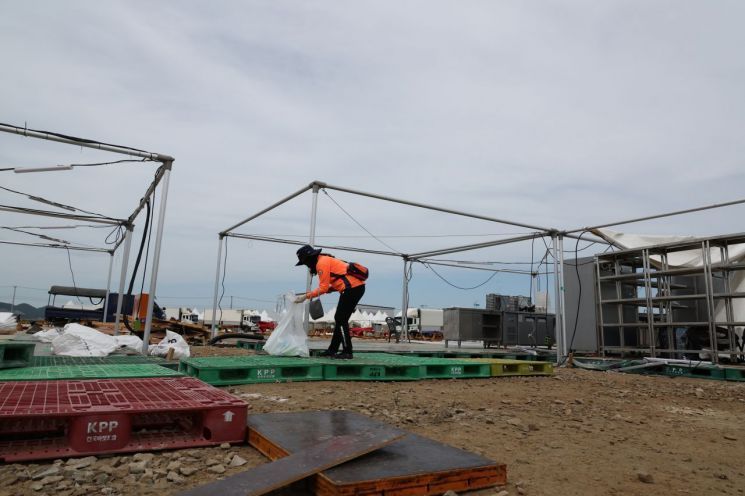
[0,363,183,381]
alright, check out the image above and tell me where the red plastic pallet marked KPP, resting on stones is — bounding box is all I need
[0,377,247,462]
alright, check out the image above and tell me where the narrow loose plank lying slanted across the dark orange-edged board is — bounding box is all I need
[180,429,405,496]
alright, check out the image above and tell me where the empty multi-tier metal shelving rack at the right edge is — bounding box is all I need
[595,233,745,363]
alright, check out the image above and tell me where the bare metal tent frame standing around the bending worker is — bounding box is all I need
[211,181,576,363]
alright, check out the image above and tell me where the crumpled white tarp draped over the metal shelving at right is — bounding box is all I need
[593,229,745,332]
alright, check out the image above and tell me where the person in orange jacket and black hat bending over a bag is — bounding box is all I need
[295,245,367,359]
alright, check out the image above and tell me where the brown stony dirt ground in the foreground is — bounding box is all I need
[0,349,745,496]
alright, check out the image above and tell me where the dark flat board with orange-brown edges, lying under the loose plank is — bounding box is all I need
[248,410,507,496]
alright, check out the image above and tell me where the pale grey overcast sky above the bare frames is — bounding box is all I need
[0,0,745,309]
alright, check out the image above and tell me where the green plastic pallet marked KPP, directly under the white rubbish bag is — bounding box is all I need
[179,355,323,386]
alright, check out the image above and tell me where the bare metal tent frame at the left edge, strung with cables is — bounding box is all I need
[0,124,175,355]
